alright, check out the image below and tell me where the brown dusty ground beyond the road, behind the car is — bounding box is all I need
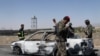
[0,32,100,46]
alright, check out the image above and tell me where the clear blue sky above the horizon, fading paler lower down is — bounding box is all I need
[0,0,100,29]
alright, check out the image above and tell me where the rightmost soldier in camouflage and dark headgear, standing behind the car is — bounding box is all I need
[84,20,94,47]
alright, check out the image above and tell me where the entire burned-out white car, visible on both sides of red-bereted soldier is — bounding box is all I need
[11,30,94,56]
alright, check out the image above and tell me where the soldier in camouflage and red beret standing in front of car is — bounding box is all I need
[56,16,70,56]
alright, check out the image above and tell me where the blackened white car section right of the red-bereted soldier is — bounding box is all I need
[66,36,96,56]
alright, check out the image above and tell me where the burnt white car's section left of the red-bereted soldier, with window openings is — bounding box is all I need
[11,30,56,56]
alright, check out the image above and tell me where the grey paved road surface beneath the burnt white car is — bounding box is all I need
[0,45,100,56]
